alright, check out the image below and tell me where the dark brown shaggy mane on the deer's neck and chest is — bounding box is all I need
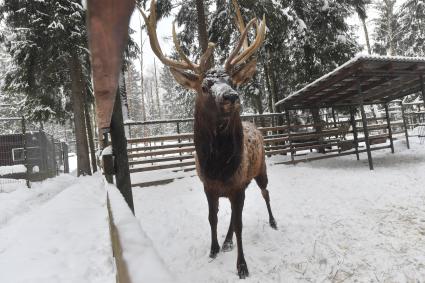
[194,96,243,182]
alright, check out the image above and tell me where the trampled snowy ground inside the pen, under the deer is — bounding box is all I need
[133,138,425,282]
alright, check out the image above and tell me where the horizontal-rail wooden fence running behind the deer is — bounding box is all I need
[126,113,412,187]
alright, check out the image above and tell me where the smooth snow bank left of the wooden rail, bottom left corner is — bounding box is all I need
[0,175,115,283]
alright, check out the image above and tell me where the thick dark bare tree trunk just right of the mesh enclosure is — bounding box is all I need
[70,54,91,176]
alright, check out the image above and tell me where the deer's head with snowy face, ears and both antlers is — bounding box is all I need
[140,0,266,121]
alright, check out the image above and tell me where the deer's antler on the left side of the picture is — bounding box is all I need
[138,0,215,75]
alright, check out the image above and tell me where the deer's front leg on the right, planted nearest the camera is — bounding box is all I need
[232,191,249,279]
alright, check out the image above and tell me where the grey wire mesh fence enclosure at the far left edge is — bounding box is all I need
[0,117,69,192]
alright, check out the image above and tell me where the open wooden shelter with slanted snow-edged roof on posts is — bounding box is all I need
[276,55,425,170]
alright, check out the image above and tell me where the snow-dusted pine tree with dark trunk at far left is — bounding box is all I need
[0,0,91,175]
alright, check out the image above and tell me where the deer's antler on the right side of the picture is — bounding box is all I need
[225,0,266,73]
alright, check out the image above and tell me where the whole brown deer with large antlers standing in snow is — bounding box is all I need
[142,0,276,278]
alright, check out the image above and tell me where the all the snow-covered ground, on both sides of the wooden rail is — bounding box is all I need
[0,138,425,283]
